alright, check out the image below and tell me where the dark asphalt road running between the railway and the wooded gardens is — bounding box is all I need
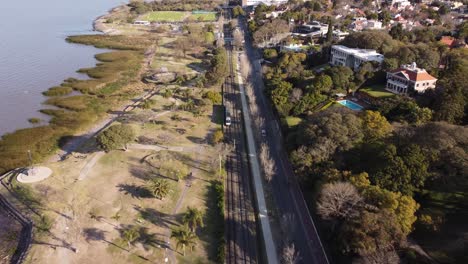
[239,17,329,264]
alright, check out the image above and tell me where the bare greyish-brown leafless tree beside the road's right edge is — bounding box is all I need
[317,182,362,220]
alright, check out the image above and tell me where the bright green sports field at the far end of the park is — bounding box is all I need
[143,11,216,22]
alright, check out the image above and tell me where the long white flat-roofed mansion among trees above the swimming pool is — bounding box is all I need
[330,45,384,71]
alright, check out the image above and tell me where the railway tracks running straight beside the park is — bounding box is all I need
[223,25,257,264]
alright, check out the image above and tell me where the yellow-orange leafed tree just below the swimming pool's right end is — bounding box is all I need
[361,110,392,140]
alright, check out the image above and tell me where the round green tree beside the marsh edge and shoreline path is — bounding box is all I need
[96,125,135,151]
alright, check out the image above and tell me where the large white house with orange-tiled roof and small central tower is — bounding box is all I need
[385,62,437,94]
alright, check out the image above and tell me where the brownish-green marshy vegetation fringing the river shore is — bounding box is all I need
[0,35,154,173]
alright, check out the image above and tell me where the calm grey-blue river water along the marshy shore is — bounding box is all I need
[0,0,127,135]
